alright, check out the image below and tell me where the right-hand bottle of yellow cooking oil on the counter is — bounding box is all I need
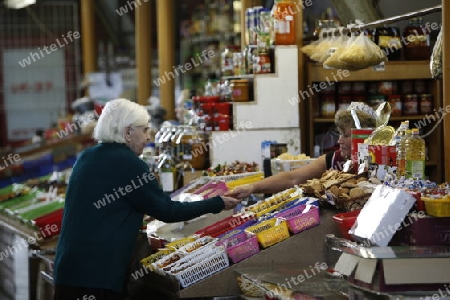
[405,128,425,179]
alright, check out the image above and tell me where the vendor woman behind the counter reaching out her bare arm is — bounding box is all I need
[226,102,376,199]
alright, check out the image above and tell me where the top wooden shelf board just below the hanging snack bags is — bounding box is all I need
[308,61,431,82]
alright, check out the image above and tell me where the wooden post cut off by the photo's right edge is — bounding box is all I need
[442,1,450,182]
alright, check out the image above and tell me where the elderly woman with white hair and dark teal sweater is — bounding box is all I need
[54,99,239,300]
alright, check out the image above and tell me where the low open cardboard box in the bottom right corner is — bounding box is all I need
[334,247,450,296]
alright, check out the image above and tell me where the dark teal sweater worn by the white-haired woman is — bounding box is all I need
[54,143,224,292]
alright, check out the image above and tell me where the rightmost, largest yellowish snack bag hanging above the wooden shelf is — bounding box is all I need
[339,32,387,70]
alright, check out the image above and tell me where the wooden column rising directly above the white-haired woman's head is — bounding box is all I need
[135,1,152,105]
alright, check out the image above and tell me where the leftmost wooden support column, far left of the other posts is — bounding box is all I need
[80,0,97,76]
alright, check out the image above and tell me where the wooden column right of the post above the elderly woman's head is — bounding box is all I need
[156,0,174,120]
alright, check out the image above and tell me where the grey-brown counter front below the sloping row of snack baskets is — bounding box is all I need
[142,209,338,299]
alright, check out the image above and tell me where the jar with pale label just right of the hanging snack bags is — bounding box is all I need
[373,25,402,60]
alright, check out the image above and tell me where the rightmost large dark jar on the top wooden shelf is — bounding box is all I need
[403,17,431,60]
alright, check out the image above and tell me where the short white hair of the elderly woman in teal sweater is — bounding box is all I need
[93,98,150,143]
